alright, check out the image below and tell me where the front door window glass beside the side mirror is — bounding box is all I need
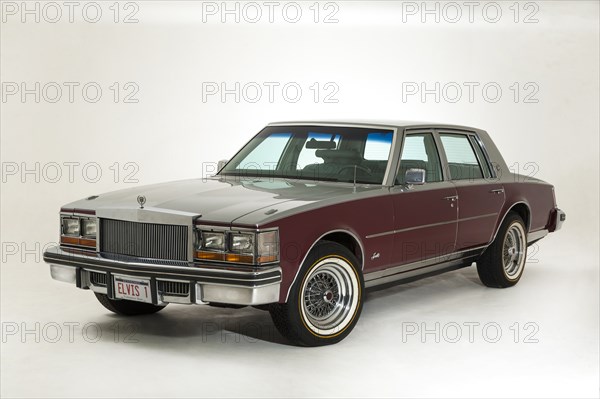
[396,133,442,184]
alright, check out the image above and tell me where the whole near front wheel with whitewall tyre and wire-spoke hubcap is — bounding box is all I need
[270,241,364,346]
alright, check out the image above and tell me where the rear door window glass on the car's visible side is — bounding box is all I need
[440,133,483,180]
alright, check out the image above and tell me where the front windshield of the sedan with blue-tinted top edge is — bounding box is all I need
[219,126,393,184]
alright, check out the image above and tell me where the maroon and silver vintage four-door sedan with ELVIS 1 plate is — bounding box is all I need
[44,121,565,346]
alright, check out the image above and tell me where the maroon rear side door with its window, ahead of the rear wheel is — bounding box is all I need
[437,130,505,251]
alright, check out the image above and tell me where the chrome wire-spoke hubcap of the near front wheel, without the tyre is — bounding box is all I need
[302,258,358,333]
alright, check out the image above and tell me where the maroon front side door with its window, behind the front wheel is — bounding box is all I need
[391,131,457,270]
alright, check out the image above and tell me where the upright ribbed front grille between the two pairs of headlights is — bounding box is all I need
[100,219,188,261]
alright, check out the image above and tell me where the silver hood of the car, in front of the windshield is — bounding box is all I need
[62,178,381,224]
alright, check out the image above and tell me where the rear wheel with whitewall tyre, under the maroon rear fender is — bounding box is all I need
[477,212,527,288]
